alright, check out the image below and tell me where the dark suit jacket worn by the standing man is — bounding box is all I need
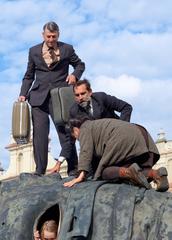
[20,42,85,106]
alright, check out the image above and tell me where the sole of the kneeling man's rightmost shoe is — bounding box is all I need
[156,167,169,192]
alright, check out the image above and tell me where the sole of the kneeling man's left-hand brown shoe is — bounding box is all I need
[129,163,152,189]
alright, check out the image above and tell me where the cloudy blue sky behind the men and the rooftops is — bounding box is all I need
[0,0,172,168]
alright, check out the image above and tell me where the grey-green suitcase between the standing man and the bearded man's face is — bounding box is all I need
[51,86,75,125]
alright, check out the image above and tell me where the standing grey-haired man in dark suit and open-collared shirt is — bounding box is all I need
[19,22,85,174]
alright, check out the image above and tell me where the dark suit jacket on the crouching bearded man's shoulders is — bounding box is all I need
[70,92,132,122]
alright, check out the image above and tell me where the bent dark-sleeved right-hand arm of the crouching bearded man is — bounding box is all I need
[103,93,133,122]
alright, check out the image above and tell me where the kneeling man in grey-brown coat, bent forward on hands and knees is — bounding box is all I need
[64,118,169,192]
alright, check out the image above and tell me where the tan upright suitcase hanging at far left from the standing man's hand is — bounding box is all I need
[12,102,30,144]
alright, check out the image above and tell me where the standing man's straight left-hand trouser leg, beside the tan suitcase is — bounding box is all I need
[32,107,49,174]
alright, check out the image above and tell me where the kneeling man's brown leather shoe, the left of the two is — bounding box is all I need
[126,163,151,189]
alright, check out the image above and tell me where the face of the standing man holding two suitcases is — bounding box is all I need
[42,28,59,48]
